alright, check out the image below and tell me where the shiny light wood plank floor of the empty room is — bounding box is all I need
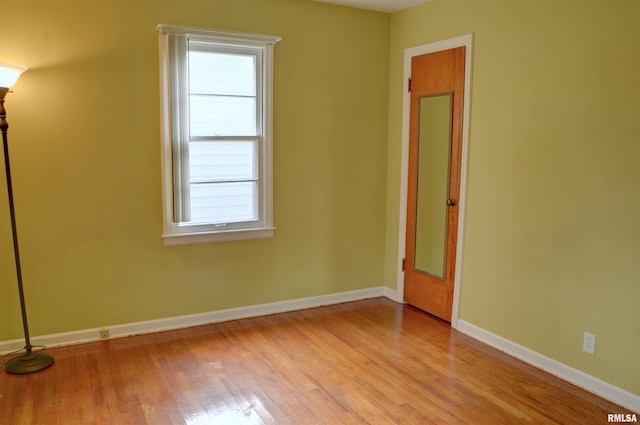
[0,298,628,425]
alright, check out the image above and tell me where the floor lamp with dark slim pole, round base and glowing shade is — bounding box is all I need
[0,62,53,375]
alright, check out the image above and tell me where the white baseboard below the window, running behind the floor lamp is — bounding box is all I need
[0,286,384,354]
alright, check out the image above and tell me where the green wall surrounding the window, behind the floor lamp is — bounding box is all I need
[0,0,390,340]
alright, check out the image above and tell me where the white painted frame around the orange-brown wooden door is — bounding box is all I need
[396,34,473,329]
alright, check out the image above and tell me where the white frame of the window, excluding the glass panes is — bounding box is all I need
[156,25,281,246]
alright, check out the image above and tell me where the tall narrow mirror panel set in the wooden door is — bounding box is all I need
[414,93,452,279]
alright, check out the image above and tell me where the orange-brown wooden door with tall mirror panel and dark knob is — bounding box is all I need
[403,47,465,322]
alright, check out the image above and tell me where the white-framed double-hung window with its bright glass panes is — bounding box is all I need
[157,25,280,245]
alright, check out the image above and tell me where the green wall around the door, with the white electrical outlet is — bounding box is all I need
[386,0,640,395]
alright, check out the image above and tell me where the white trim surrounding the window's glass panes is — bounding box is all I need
[156,25,282,246]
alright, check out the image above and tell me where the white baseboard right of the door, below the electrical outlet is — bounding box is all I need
[456,319,640,413]
